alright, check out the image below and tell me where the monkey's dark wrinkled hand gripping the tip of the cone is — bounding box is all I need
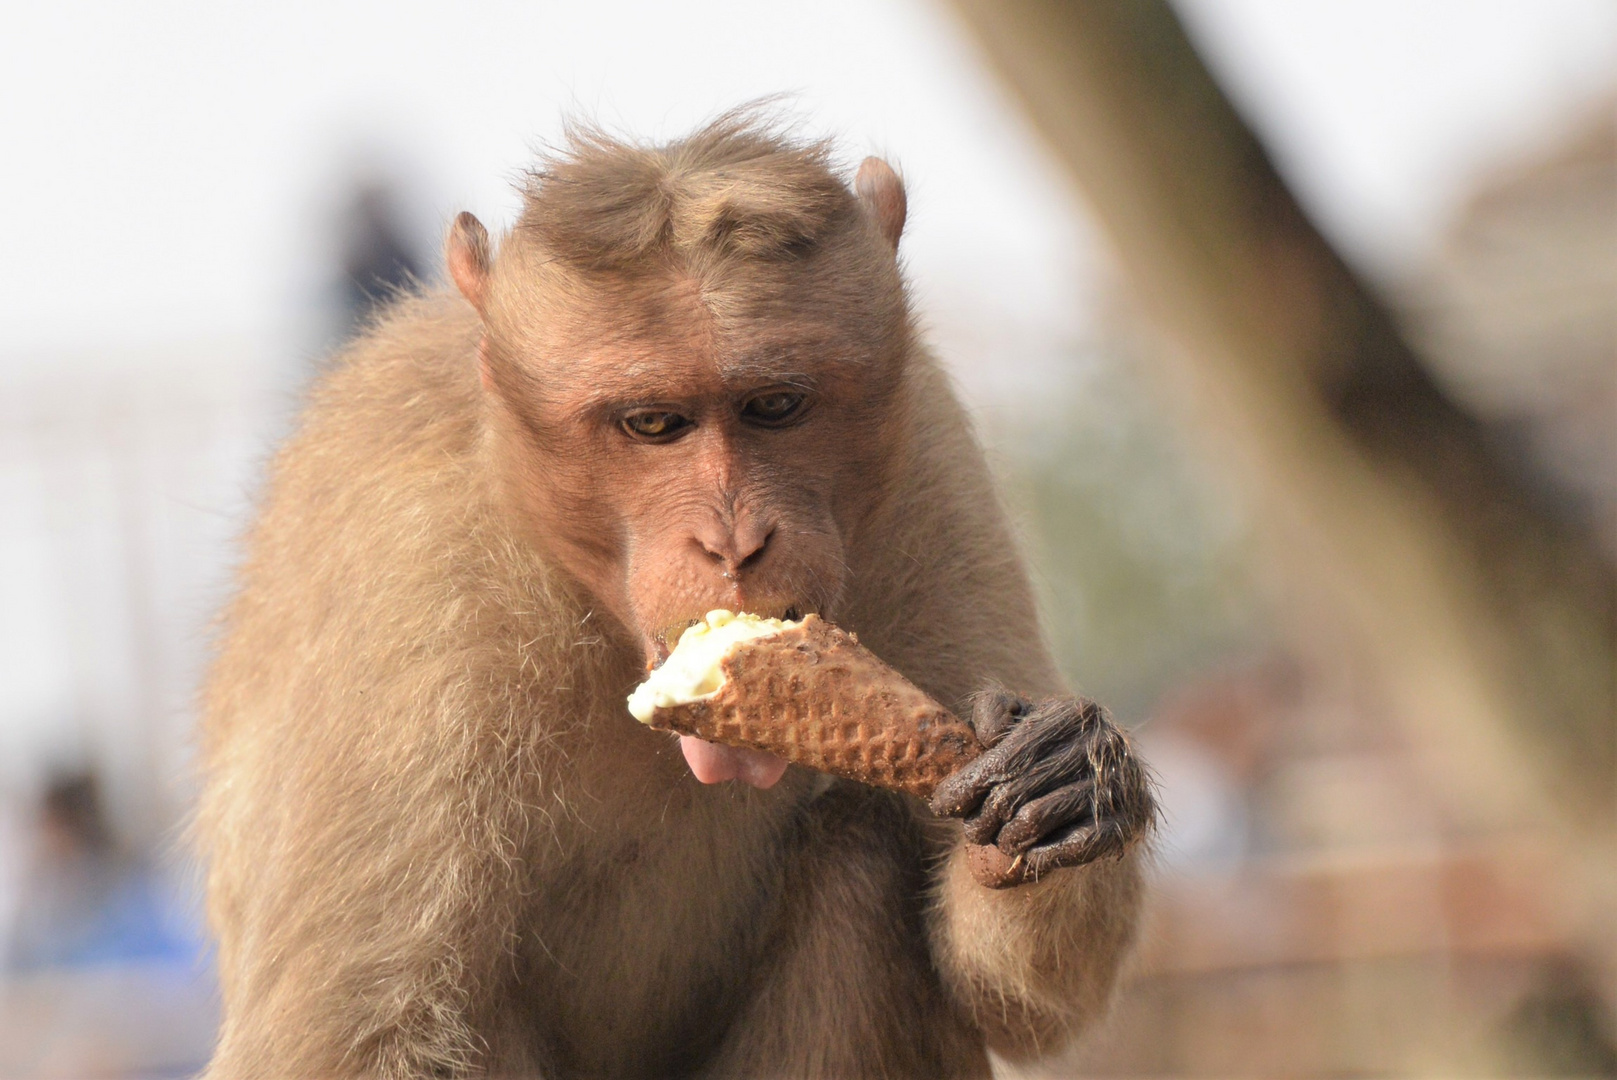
[931,690,1156,888]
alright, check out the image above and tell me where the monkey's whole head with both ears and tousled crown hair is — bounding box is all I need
[448,118,912,717]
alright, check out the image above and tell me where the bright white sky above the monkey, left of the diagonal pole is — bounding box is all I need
[0,0,1085,368]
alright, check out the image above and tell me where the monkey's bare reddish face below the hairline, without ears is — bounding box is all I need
[487,258,907,661]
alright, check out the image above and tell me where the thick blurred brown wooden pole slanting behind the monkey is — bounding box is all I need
[952,0,1617,918]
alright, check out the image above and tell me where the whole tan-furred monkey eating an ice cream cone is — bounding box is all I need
[194,110,1155,1080]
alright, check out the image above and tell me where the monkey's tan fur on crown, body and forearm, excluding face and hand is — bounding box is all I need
[197,116,1138,1078]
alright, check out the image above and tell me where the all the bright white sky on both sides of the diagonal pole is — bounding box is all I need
[0,0,1617,375]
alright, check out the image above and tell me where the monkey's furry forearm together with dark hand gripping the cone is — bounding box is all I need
[931,692,1156,1056]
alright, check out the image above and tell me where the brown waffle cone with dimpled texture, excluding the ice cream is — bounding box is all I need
[650,614,982,799]
